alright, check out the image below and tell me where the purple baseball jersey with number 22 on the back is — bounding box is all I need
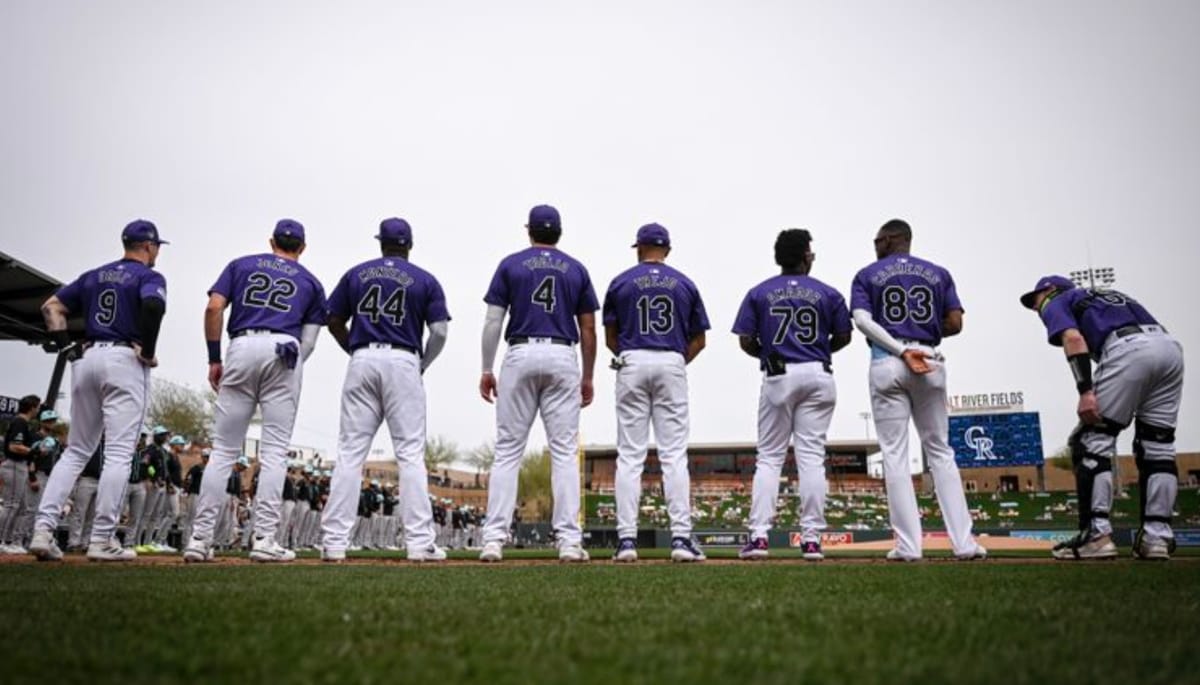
[209,254,325,338]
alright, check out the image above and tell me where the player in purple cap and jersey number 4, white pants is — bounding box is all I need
[479,205,599,561]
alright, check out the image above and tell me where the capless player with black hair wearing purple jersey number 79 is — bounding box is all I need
[733,228,851,561]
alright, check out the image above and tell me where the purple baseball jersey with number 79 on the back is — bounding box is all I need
[733,274,851,363]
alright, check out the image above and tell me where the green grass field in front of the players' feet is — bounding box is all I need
[0,554,1200,685]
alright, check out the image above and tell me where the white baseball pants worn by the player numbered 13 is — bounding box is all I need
[616,349,691,539]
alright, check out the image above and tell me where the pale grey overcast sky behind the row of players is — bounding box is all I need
[0,0,1200,465]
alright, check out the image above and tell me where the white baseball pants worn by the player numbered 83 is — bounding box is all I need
[870,345,976,557]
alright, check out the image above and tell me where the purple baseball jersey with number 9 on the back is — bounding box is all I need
[58,259,167,342]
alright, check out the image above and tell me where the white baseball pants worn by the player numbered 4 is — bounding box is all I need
[484,342,583,546]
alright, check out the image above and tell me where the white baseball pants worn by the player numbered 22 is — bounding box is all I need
[192,334,304,541]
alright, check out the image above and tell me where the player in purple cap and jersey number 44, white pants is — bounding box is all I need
[322,218,450,561]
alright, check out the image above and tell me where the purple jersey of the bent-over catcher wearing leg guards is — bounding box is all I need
[1039,288,1158,356]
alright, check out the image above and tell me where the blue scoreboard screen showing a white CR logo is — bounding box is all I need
[950,411,1045,469]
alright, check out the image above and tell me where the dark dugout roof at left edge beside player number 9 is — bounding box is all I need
[0,252,83,345]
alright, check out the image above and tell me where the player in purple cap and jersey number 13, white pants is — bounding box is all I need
[604,223,709,561]
